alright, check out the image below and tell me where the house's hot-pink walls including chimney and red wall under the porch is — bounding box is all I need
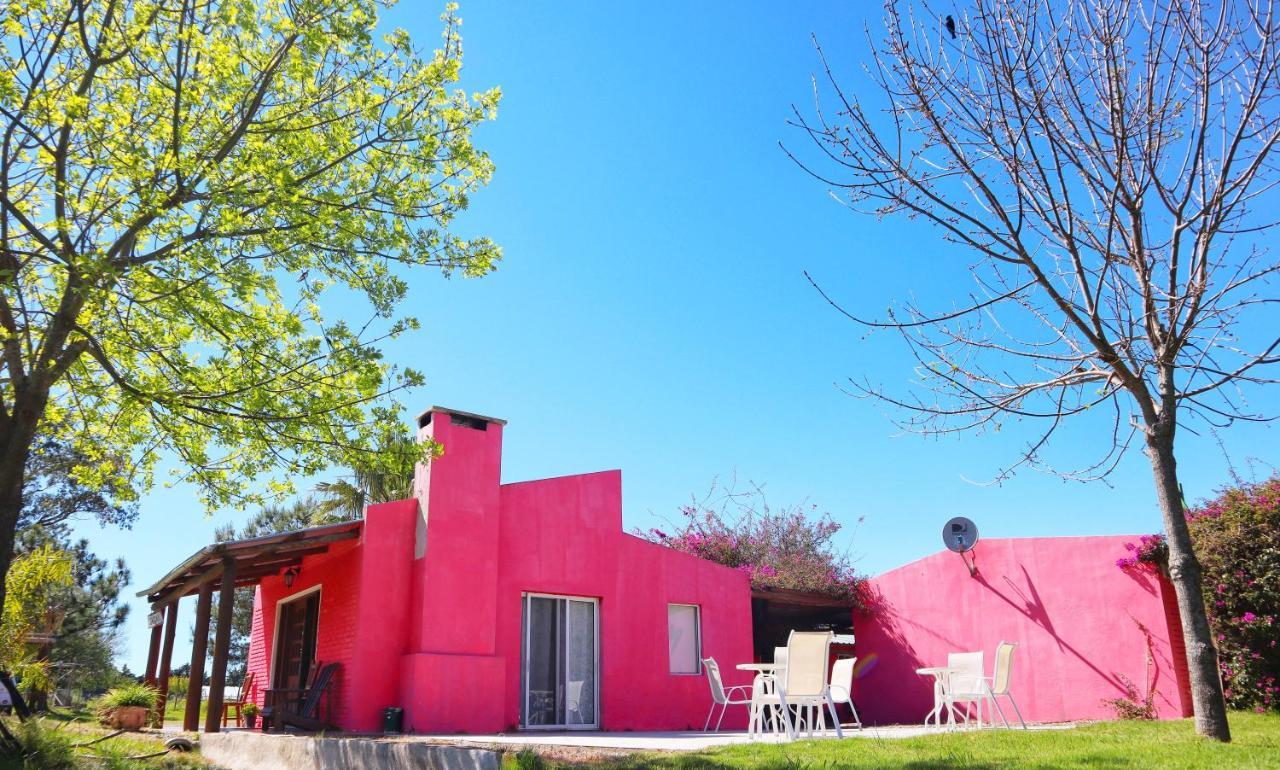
[250,413,751,733]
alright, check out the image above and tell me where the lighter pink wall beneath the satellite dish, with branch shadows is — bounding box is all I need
[856,536,1190,724]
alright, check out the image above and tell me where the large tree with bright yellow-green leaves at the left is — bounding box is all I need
[0,0,500,611]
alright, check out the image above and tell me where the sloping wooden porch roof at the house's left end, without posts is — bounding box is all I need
[138,519,364,605]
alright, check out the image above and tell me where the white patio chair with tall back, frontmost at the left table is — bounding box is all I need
[751,631,845,741]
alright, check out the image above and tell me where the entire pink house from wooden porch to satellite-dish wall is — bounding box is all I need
[142,407,1188,733]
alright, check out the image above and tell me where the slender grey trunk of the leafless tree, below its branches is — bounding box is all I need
[1147,424,1231,742]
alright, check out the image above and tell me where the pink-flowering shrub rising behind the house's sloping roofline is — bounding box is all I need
[637,475,867,605]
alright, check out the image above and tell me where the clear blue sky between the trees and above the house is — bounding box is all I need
[81,1,1280,670]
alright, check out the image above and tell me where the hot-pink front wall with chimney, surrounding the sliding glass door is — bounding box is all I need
[401,404,751,732]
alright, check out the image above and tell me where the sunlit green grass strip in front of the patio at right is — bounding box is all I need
[568,712,1280,770]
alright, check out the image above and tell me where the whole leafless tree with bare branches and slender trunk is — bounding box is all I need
[788,0,1280,741]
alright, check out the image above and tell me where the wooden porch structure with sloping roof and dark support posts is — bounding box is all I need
[138,521,364,733]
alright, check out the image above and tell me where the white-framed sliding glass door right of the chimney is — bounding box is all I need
[520,593,600,729]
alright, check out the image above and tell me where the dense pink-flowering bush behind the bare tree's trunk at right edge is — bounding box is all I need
[1116,476,1280,711]
